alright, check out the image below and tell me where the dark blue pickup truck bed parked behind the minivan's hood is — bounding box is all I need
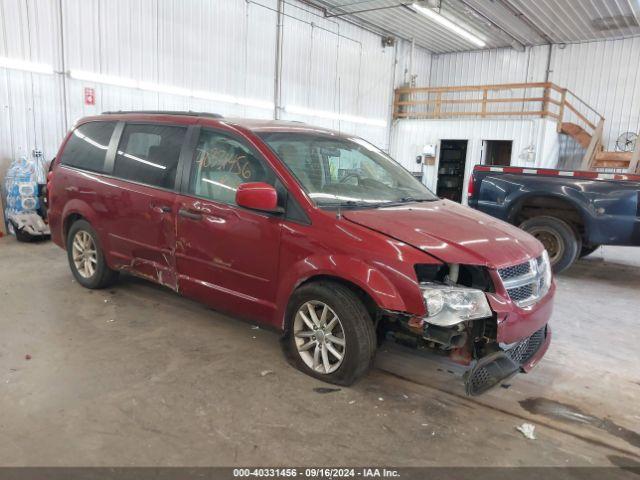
[467,165,640,273]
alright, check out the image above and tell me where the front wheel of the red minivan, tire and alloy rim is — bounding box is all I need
[283,282,377,385]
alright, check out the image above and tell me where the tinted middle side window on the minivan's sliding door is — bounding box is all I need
[113,124,187,189]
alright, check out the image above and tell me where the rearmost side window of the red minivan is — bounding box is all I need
[60,122,116,173]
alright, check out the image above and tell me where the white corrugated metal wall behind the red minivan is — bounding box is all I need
[0,0,431,182]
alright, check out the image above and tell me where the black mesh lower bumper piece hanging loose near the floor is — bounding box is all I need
[464,325,547,396]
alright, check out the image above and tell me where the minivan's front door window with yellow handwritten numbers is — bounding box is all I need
[189,130,276,204]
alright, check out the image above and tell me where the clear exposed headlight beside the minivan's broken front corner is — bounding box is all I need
[420,283,492,327]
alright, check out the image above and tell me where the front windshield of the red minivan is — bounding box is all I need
[260,132,437,207]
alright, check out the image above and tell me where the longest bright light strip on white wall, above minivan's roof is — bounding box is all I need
[69,70,274,110]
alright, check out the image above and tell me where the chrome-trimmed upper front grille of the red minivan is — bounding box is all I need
[498,257,548,307]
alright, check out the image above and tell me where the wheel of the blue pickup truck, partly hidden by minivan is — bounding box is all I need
[520,216,581,273]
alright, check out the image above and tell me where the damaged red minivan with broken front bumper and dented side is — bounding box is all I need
[47,112,555,394]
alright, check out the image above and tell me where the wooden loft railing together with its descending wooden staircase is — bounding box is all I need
[393,82,640,174]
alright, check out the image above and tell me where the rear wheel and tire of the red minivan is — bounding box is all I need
[67,220,118,289]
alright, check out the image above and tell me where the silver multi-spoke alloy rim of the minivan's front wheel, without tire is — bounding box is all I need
[293,300,346,374]
